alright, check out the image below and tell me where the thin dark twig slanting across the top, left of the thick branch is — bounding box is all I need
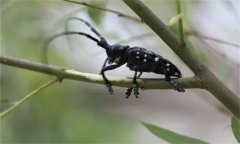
[64,0,142,23]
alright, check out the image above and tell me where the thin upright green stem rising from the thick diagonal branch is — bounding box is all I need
[176,0,185,45]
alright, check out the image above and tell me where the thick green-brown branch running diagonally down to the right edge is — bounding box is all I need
[123,0,240,118]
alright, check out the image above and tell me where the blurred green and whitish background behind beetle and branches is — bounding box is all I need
[0,0,240,144]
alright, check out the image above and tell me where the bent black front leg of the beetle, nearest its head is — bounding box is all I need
[100,64,121,94]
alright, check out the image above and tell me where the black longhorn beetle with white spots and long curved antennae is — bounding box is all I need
[44,17,185,98]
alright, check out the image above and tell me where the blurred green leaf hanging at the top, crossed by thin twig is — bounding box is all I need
[87,0,106,25]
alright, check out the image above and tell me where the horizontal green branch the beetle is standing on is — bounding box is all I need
[0,56,201,89]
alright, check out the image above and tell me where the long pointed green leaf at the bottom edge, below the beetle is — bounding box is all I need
[143,123,207,144]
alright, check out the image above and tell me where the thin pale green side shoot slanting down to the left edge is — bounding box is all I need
[0,78,59,118]
